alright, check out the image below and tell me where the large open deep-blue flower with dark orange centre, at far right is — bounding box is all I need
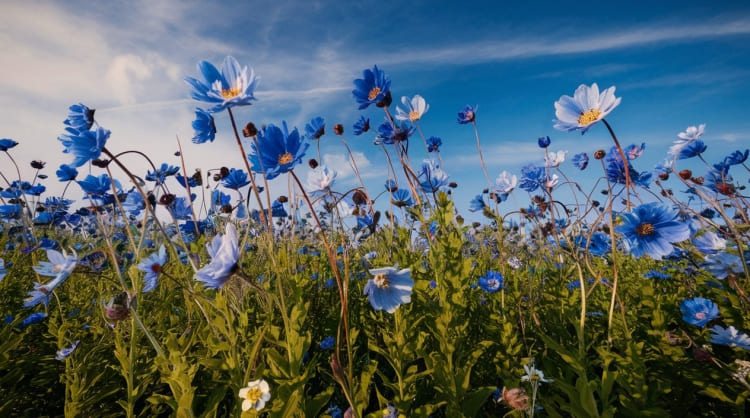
[616,202,690,260]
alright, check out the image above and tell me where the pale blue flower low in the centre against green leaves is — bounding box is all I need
[364,267,414,313]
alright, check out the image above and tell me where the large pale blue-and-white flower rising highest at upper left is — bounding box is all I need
[185,56,259,112]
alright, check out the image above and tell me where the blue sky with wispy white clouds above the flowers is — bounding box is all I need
[0,1,750,219]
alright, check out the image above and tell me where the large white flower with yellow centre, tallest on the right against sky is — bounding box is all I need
[554,83,621,134]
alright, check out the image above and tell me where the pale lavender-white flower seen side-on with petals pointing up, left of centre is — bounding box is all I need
[195,223,240,289]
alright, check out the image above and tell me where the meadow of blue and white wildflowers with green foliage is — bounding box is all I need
[0,46,750,418]
